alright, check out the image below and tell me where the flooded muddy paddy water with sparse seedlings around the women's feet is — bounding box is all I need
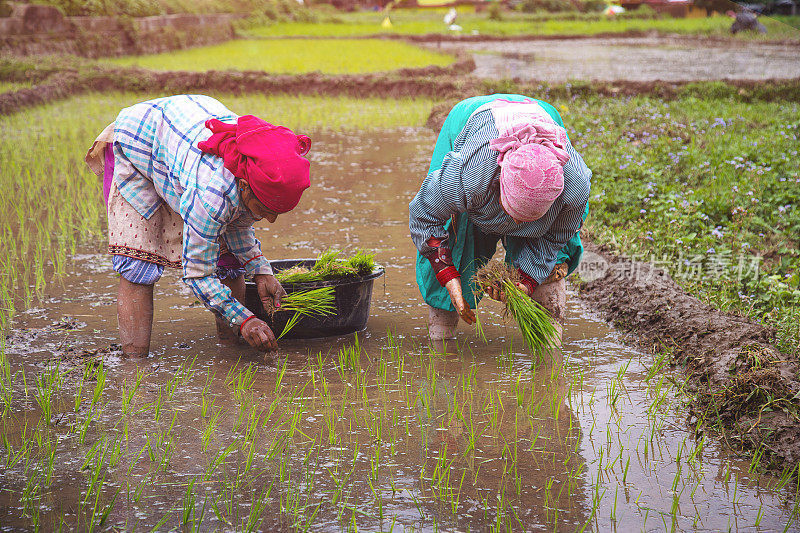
[0,130,795,531]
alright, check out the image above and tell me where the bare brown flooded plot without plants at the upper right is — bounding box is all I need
[428,38,800,82]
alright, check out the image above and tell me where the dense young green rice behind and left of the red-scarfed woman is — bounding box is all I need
[0,93,431,329]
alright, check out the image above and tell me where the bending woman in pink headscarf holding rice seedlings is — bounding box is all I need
[409,94,592,339]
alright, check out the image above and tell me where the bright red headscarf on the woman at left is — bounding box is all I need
[197,115,311,213]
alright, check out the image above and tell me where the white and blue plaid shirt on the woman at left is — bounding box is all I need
[114,95,272,325]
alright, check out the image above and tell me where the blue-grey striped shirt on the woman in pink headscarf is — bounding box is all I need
[409,103,592,283]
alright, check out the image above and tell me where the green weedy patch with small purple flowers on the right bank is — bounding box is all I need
[562,95,800,353]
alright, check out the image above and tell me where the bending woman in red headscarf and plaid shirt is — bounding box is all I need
[86,95,311,357]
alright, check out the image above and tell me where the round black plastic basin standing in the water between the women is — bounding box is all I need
[245,259,383,339]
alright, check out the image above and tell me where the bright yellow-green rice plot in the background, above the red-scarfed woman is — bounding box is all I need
[108,39,454,74]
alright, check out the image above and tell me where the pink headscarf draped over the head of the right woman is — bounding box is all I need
[489,100,569,222]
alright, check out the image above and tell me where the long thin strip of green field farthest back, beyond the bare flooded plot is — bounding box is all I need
[241,10,800,41]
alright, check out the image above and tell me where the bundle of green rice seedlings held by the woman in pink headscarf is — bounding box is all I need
[473,261,558,357]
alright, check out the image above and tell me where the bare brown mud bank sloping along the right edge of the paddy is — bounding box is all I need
[580,244,800,468]
